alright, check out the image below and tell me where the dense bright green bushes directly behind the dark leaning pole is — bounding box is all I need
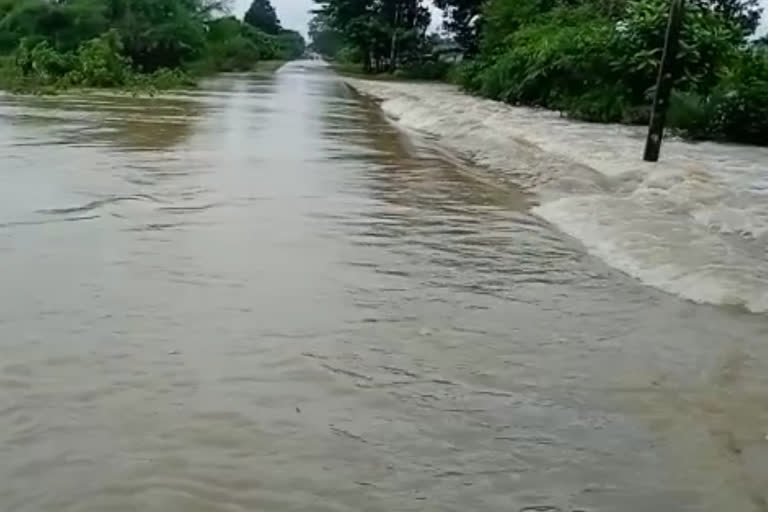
[454,0,768,144]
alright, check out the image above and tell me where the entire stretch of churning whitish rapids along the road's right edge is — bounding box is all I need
[351,80,768,312]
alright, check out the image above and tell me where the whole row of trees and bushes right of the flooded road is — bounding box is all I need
[312,0,768,145]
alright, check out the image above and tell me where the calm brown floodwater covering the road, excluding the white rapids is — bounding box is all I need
[0,62,768,512]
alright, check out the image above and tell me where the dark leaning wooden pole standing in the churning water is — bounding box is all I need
[643,0,684,162]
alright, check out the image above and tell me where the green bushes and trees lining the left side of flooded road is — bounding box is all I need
[0,0,304,91]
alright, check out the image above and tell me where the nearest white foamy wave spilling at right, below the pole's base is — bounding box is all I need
[535,196,768,312]
